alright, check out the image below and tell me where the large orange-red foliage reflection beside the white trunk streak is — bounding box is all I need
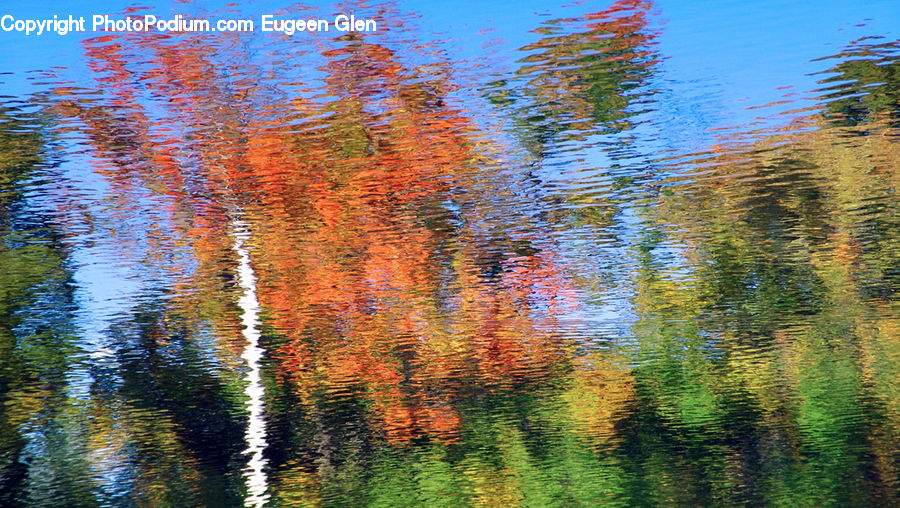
[60,12,592,443]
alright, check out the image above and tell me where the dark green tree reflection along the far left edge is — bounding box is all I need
[0,102,95,506]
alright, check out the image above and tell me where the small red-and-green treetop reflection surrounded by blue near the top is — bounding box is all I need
[489,0,658,158]
